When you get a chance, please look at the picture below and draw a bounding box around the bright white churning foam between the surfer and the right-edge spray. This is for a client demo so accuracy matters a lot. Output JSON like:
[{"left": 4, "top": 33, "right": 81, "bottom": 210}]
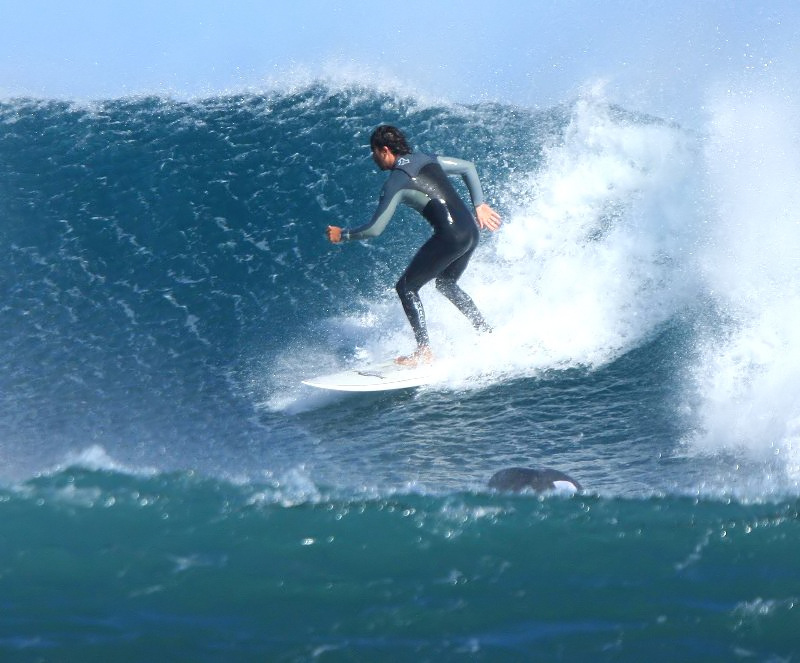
[{"left": 476, "top": 95, "right": 698, "bottom": 374}]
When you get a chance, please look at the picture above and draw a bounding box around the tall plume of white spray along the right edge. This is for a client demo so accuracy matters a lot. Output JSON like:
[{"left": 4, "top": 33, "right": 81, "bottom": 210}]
[{"left": 693, "top": 86, "right": 800, "bottom": 481}]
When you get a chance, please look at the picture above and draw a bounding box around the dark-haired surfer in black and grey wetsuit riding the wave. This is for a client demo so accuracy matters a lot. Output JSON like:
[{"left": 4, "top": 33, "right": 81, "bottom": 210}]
[{"left": 327, "top": 125, "right": 500, "bottom": 366}]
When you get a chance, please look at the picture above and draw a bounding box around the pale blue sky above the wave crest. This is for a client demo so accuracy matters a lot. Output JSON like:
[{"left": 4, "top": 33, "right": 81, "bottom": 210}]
[{"left": 0, "top": 0, "right": 800, "bottom": 123}]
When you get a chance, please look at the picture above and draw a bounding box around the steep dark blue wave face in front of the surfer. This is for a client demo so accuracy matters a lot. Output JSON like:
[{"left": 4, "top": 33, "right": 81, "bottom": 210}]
[{"left": 0, "top": 86, "right": 552, "bottom": 482}]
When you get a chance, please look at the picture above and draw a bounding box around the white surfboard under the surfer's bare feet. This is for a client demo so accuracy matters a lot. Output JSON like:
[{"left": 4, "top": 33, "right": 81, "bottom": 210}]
[{"left": 303, "top": 361, "right": 444, "bottom": 391}]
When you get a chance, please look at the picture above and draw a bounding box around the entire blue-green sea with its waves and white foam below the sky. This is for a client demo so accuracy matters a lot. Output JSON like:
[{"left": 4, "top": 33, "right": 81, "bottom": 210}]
[{"left": 0, "top": 83, "right": 800, "bottom": 662}]
